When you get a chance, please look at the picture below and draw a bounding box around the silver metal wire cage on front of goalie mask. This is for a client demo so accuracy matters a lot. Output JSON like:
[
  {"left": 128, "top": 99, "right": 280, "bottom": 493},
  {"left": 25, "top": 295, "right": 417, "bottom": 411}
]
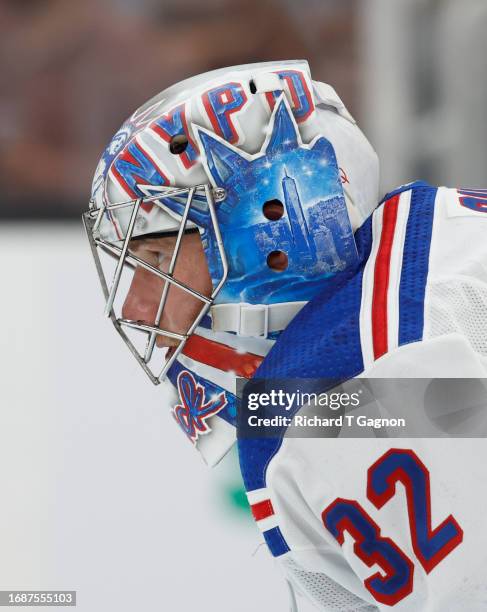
[{"left": 83, "top": 184, "right": 228, "bottom": 385}]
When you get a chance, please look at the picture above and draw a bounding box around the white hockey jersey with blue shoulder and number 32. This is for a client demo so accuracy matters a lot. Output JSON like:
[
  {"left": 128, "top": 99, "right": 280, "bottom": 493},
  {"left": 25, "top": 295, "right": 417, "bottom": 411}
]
[{"left": 239, "top": 183, "right": 487, "bottom": 612}]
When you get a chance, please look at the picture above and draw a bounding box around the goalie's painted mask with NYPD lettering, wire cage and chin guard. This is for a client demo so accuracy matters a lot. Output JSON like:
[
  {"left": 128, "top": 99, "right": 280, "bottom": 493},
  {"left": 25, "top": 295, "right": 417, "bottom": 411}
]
[{"left": 84, "top": 62, "right": 378, "bottom": 463}]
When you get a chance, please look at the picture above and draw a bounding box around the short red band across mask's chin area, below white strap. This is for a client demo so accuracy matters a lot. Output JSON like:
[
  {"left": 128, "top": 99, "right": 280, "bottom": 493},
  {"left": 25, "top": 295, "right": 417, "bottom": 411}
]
[{"left": 183, "top": 335, "right": 264, "bottom": 378}]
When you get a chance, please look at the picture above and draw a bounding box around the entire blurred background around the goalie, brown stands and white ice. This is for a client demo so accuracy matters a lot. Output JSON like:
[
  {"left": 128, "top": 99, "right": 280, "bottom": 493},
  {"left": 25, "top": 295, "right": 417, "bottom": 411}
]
[{"left": 0, "top": 0, "right": 487, "bottom": 612}]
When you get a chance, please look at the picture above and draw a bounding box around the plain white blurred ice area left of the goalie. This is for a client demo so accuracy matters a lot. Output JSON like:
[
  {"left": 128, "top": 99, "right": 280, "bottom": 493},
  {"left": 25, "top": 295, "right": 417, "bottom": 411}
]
[{"left": 0, "top": 223, "right": 316, "bottom": 612}]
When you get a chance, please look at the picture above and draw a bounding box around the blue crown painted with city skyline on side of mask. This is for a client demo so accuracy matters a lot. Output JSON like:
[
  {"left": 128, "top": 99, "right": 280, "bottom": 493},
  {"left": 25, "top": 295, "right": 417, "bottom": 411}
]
[{"left": 194, "top": 96, "right": 357, "bottom": 303}]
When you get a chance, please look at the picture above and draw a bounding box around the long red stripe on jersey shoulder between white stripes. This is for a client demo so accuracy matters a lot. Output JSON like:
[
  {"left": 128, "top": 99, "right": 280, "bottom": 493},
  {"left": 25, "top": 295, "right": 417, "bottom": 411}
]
[{"left": 372, "top": 195, "right": 399, "bottom": 359}]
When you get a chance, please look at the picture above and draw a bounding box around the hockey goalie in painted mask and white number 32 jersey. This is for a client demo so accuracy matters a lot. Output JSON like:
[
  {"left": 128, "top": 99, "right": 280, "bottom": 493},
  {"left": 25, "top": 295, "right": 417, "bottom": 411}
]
[{"left": 84, "top": 61, "right": 487, "bottom": 612}]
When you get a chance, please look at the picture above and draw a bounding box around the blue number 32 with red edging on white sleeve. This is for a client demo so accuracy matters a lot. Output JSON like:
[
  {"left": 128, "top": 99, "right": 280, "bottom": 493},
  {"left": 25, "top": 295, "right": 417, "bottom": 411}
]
[{"left": 322, "top": 449, "right": 463, "bottom": 606}]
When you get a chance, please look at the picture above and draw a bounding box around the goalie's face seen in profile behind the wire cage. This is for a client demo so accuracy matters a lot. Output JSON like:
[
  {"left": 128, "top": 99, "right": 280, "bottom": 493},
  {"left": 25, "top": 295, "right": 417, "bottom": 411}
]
[{"left": 122, "top": 232, "right": 212, "bottom": 357}]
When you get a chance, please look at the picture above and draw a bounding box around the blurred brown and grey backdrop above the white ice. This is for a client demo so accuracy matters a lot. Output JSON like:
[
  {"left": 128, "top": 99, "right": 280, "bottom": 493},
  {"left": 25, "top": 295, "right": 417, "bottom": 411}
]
[{"left": 0, "top": 0, "right": 487, "bottom": 219}]
